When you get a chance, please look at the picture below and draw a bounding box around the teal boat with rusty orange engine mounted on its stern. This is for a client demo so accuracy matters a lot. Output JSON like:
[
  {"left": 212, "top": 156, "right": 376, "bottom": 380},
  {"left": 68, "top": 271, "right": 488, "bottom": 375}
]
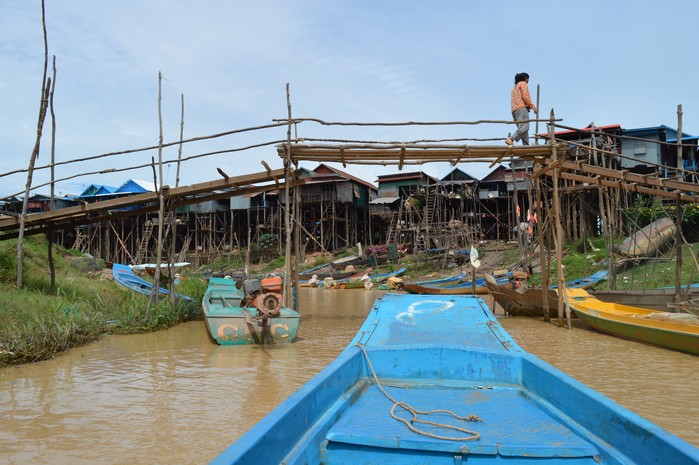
[{"left": 202, "top": 278, "right": 300, "bottom": 345}]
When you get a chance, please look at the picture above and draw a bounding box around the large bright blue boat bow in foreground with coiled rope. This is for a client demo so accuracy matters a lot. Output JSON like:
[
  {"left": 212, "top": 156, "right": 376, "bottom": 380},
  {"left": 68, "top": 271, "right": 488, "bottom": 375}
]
[{"left": 211, "top": 294, "right": 699, "bottom": 465}]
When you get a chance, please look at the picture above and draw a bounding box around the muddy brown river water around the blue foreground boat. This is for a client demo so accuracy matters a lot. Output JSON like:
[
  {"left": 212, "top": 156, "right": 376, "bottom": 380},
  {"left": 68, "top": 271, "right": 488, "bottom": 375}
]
[{"left": 0, "top": 289, "right": 699, "bottom": 464}]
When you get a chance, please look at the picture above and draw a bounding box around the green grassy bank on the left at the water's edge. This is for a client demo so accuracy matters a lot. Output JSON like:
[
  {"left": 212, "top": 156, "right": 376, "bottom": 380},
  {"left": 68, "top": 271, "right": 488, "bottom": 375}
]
[{"left": 0, "top": 236, "right": 206, "bottom": 366}]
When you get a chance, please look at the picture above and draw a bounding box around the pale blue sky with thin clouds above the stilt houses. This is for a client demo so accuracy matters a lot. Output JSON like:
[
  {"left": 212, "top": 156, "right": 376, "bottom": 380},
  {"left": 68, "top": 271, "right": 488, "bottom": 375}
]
[{"left": 0, "top": 0, "right": 699, "bottom": 197}]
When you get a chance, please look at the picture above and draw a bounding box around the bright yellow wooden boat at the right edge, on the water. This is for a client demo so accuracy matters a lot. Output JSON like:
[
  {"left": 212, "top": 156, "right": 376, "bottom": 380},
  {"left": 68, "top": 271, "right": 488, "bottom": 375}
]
[{"left": 566, "top": 289, "right": 699, "bottom": 354}]
